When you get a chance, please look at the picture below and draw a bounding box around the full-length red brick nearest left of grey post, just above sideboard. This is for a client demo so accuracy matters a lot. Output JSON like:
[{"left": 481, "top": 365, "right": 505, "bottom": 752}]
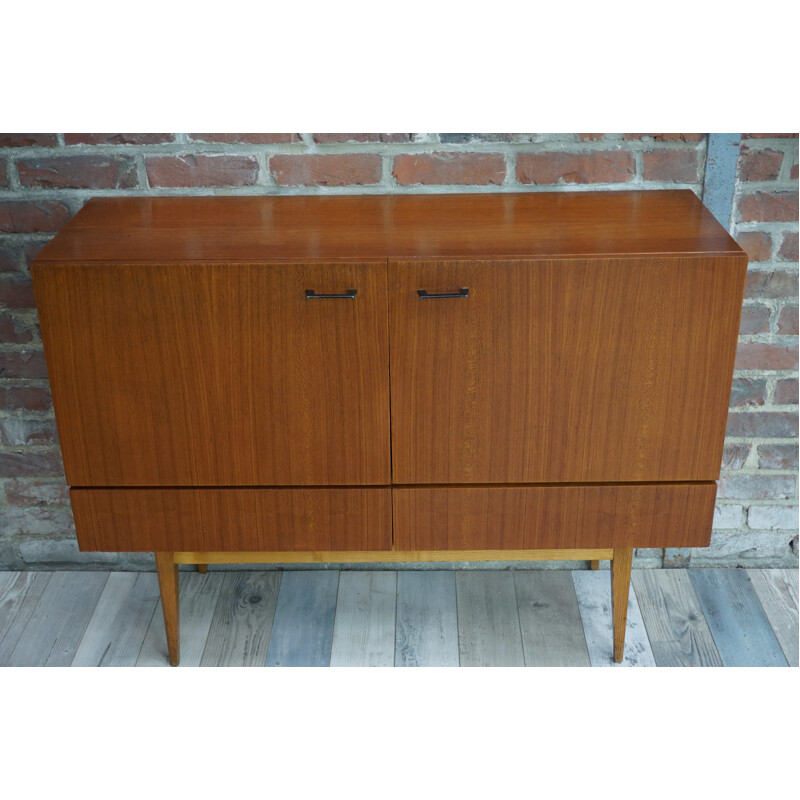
[{"left": 517, "top": 150, "right": 634, "bottom": 184}]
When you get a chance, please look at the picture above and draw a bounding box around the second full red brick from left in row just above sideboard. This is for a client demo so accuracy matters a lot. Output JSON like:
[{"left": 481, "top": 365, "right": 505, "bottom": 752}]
[{"left": 145, "top": 155, "right": 258, "bottom": 187}]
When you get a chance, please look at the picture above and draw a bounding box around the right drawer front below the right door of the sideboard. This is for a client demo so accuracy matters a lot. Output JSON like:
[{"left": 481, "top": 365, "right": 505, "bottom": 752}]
[{"left": 392, "top": 482, "right": 717, "bottom": 551}]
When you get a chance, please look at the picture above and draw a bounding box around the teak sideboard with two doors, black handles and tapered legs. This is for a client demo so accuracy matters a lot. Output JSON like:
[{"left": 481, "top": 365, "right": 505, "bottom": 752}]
[{"left": 32, "top": 191, "right": 747, "bottom": 664}]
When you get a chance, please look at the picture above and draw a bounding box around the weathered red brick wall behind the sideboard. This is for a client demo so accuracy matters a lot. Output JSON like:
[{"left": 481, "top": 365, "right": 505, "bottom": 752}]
[{"left": 0, "top": 133, "right": 798, "bottom": 568}]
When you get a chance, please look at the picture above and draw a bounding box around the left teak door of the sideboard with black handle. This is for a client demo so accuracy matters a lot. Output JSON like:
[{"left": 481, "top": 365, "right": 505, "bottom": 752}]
[{"left": 33, "top": 262, "right": 390, "bottom": 486}]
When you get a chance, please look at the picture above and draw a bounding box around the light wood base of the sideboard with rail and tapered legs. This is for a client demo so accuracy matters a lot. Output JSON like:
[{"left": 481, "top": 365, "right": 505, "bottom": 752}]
[{"left": 155, "top": 547, "right": 633, "bottom": 667}]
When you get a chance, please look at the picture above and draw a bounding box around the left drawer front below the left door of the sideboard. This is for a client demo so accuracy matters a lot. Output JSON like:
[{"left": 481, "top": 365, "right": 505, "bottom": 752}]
[{"left": 70, "top": 488, "right": 392, "bottom": 552}]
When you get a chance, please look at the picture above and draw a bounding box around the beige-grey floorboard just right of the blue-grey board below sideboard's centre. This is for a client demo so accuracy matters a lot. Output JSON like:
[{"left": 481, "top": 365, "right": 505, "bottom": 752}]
[{"left": 456, "top": 570, "right": 525, "bottom": 667}]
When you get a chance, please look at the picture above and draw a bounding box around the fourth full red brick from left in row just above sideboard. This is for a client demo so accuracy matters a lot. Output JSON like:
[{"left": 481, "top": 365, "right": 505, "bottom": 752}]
[{"left": 392, "top": 152, "right": 506, "bottom": 186}]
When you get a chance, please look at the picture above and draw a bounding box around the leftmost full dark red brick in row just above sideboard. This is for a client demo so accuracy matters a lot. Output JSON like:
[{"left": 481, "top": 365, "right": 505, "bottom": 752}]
[{"left": 17, "top": 155, "right": 139, "bottom": 189}]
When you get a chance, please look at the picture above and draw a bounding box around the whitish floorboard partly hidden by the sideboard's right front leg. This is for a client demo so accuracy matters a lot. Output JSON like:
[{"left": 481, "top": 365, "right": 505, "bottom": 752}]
[{"left": 572, "top": 570, "right": 656, "bottom": 667}]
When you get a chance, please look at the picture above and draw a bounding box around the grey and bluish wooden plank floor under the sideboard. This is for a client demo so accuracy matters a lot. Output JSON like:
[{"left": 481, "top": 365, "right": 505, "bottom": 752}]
[{"left": 0, "top": 569, "right": 798, "bottom": 667}]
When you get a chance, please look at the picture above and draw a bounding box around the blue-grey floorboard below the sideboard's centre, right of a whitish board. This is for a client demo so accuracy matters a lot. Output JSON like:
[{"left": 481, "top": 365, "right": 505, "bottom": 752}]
[{"left": 394, "top": 570, "right": 458, "bottom": 667}]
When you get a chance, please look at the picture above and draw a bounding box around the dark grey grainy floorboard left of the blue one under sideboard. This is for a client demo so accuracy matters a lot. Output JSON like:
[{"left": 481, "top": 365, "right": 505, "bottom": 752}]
[{"left": 200, "top": 571, "right": 281, "bottom": 667}]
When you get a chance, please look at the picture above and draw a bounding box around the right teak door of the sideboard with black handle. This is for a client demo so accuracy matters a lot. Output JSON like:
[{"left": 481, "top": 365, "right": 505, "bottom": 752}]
[{"left": 389, "top": 257, "right": 746, "bottom": 484}]
